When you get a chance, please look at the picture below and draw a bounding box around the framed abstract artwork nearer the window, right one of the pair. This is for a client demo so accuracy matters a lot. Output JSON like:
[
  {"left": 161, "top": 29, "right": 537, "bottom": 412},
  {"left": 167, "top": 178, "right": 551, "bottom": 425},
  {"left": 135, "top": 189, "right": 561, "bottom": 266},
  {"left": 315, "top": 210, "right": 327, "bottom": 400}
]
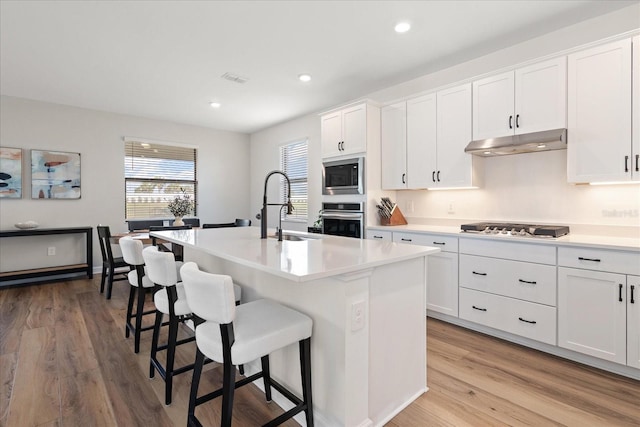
[{"left": 31, "top": 150, "right": 80, "bottom": 199}]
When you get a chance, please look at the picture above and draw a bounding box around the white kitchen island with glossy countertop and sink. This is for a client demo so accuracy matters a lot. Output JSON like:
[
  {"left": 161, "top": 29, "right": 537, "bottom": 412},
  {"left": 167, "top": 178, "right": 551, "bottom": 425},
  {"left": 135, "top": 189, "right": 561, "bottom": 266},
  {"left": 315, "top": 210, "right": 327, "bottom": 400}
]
[{"left": 151, "top": 227, "right": 439, "bottom": 427}]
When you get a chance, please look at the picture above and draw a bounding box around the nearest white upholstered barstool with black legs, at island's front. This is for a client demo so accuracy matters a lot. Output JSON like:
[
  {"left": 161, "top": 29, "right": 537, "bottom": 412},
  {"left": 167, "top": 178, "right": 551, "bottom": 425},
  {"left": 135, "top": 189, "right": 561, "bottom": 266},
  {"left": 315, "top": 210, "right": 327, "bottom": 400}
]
[{"left": 180, "top": 262, "right": 313, "bottom": 427}]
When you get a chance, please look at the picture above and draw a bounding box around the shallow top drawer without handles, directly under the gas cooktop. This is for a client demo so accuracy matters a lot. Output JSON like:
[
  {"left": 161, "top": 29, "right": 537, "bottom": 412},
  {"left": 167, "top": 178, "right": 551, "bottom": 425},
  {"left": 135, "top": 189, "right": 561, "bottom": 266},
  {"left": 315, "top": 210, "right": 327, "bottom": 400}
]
[{"left": 460, "top": 238, "right": 556, "bottom": 265}]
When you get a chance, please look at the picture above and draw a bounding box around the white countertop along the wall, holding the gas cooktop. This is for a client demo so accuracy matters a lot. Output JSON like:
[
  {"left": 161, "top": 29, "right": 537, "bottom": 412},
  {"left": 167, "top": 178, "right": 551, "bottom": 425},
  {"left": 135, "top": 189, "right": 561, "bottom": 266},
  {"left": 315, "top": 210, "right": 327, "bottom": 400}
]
[{"left": 367, "top": 224, "right": 640, "bottom": 252}]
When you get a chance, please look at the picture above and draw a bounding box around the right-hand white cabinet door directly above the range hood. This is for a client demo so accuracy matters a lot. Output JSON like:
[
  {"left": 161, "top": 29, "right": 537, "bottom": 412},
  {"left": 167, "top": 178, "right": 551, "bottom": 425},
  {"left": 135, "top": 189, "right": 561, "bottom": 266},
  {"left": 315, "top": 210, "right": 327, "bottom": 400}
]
[{"left": 514, "top": 56, "right": 567, "bottom": 134}]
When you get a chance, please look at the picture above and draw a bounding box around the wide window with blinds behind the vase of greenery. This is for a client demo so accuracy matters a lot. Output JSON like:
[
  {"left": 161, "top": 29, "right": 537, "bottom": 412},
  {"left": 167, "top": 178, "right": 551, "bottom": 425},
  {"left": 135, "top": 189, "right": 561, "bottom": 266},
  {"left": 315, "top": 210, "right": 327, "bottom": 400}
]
[{"left": 124, "top": 140, "right": 198, "bottom": 219}]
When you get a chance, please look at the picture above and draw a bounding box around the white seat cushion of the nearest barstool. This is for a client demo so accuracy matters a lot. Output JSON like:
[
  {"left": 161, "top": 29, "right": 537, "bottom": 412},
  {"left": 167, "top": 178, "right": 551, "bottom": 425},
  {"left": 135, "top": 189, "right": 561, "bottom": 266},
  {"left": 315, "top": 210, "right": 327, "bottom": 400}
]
[{"left": 196, "top": 299, "right": 313, "bottom": 365}]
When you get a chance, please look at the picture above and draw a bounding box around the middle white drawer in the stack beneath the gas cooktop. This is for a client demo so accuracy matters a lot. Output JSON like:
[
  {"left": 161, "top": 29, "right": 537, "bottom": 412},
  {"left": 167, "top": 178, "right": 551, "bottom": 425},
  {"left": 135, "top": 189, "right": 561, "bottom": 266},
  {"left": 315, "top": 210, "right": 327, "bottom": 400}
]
[{"left": 460, "top": 254, "right": 556, "bottom": 306}]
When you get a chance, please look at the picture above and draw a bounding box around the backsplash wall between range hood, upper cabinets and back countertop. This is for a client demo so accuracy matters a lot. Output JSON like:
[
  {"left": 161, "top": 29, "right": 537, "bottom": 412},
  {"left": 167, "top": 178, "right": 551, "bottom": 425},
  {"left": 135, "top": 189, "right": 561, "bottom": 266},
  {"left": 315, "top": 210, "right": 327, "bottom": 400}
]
[{"left": 396, "top": 150, "right": 640, "bottom": 231}]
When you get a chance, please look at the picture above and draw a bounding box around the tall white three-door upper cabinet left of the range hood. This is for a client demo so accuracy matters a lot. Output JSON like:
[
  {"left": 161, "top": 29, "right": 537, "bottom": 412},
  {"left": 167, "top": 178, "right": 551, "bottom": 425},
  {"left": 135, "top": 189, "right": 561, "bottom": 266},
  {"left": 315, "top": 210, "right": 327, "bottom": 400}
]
[{"left": 382, "top": 83, "right": 477, "bottom": 190}]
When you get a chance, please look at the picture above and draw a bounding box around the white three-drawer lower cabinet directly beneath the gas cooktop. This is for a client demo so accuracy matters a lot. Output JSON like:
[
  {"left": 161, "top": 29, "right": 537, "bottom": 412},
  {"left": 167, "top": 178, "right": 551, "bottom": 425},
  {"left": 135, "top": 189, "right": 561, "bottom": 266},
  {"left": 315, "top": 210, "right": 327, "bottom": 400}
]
[{"left": 459, "top": 239, "right": 557, "bottom": 345}]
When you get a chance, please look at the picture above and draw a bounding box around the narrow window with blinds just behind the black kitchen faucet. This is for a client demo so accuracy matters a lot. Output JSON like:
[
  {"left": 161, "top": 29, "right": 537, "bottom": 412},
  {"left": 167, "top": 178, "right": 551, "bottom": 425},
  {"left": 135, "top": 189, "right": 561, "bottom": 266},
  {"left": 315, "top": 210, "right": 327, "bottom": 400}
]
[{"left": 280, "top": 140, "right": 308, "bottom": 221}]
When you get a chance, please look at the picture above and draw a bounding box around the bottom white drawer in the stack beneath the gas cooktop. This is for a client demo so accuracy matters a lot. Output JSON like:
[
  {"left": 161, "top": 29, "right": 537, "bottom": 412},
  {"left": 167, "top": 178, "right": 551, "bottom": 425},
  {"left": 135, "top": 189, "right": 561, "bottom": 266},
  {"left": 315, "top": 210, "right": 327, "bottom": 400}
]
[{"left": 459, "top": 288, "right": 557, "bottom": 345}]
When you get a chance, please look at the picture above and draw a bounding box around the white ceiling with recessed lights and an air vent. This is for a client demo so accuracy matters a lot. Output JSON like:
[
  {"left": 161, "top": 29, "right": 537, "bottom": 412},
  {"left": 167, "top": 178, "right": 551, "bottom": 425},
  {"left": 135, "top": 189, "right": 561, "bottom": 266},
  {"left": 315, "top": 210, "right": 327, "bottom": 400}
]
[{"left": 0, "top": 0, "right": 638, "bottom": 133}]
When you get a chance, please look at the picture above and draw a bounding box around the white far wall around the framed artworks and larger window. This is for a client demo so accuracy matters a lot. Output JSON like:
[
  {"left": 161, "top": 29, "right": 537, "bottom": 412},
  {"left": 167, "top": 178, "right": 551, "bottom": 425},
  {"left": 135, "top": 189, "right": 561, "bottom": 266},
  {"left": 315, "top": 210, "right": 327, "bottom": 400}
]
[{"left": 0, "top": 96, "right": 250, "bottom": 269}]
